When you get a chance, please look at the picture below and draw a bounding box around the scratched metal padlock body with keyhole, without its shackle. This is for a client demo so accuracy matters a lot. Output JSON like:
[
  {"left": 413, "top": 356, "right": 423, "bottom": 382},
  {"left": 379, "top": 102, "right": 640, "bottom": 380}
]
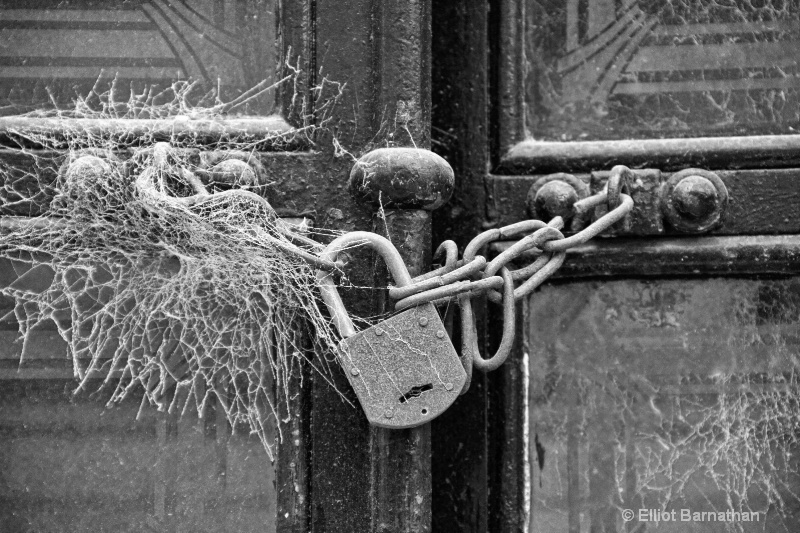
[{"left": 339, "top": 304, "right": 467, "bottom": 428}]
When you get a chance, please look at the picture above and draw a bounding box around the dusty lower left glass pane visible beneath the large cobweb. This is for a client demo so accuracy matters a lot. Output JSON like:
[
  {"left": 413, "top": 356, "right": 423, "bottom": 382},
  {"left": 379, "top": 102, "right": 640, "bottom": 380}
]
[{"left": 0, "top": 379, "right": 277, "bottom": 533}]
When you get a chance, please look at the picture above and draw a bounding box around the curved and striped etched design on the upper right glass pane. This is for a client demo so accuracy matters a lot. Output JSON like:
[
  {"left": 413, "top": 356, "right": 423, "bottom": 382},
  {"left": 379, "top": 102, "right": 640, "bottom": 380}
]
[{"left": 556, "top": 0, "right": 800, "bottom": 105}]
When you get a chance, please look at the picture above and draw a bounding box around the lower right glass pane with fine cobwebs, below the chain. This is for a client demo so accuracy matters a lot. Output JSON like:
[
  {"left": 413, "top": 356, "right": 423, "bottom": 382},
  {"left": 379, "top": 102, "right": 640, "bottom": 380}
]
[{"left": 527, "top": 279, "right": 800, "bottom": 533}]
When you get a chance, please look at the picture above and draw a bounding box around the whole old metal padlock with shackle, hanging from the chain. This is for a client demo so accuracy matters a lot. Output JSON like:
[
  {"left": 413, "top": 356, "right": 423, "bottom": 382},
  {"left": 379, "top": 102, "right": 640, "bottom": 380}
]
[{"left": 317, "top": 231, "right": 467, "bottom": 428}]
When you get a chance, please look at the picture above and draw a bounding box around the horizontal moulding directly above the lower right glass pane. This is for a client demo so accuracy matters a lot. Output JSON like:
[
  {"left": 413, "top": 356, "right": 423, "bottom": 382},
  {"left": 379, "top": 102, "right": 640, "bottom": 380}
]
[{"left": 491, "top": 235, "right": 800, "bottom": 279}]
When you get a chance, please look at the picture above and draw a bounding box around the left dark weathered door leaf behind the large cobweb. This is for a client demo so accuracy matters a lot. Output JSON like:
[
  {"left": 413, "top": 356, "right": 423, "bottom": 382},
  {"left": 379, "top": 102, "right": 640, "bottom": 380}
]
[{"left": 0, "top": 0, "right": 433, "bottom": 532}]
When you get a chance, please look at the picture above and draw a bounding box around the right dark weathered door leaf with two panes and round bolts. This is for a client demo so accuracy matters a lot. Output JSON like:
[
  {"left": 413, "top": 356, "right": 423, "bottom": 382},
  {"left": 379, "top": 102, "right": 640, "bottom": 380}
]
[{"left": 434, "top": 0, "right": 800, "bottom": 533}]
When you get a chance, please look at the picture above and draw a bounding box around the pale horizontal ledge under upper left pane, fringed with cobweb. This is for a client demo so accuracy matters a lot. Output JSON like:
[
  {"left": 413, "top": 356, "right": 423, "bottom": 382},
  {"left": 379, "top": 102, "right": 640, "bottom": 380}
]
[{"left": 0, "top": 115, "right": 307, "bottom": 150}]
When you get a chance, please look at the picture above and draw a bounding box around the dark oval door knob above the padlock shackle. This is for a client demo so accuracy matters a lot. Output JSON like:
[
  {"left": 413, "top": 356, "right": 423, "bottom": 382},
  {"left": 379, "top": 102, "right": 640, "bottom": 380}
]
[{"left": 350, "top": 148, "right": 455, "bottom": 210}]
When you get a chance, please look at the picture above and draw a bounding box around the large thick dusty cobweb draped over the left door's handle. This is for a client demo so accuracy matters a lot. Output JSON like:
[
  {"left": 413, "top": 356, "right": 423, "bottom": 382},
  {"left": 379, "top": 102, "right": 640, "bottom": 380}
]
[{"left": 0, "top": 72, "right": 354, "bottom": 458}]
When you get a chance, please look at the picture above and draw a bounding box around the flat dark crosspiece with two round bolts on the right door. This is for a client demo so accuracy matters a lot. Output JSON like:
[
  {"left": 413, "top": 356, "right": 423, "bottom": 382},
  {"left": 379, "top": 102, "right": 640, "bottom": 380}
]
[{"left": 487, "top": 164, "right": 800, "bottom": 236}]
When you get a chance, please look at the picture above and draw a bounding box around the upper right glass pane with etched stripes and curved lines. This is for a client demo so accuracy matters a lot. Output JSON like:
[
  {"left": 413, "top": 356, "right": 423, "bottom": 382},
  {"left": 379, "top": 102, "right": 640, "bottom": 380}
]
[{"left": 526, "top": 0, "right": 800, "bottom": 140}]
